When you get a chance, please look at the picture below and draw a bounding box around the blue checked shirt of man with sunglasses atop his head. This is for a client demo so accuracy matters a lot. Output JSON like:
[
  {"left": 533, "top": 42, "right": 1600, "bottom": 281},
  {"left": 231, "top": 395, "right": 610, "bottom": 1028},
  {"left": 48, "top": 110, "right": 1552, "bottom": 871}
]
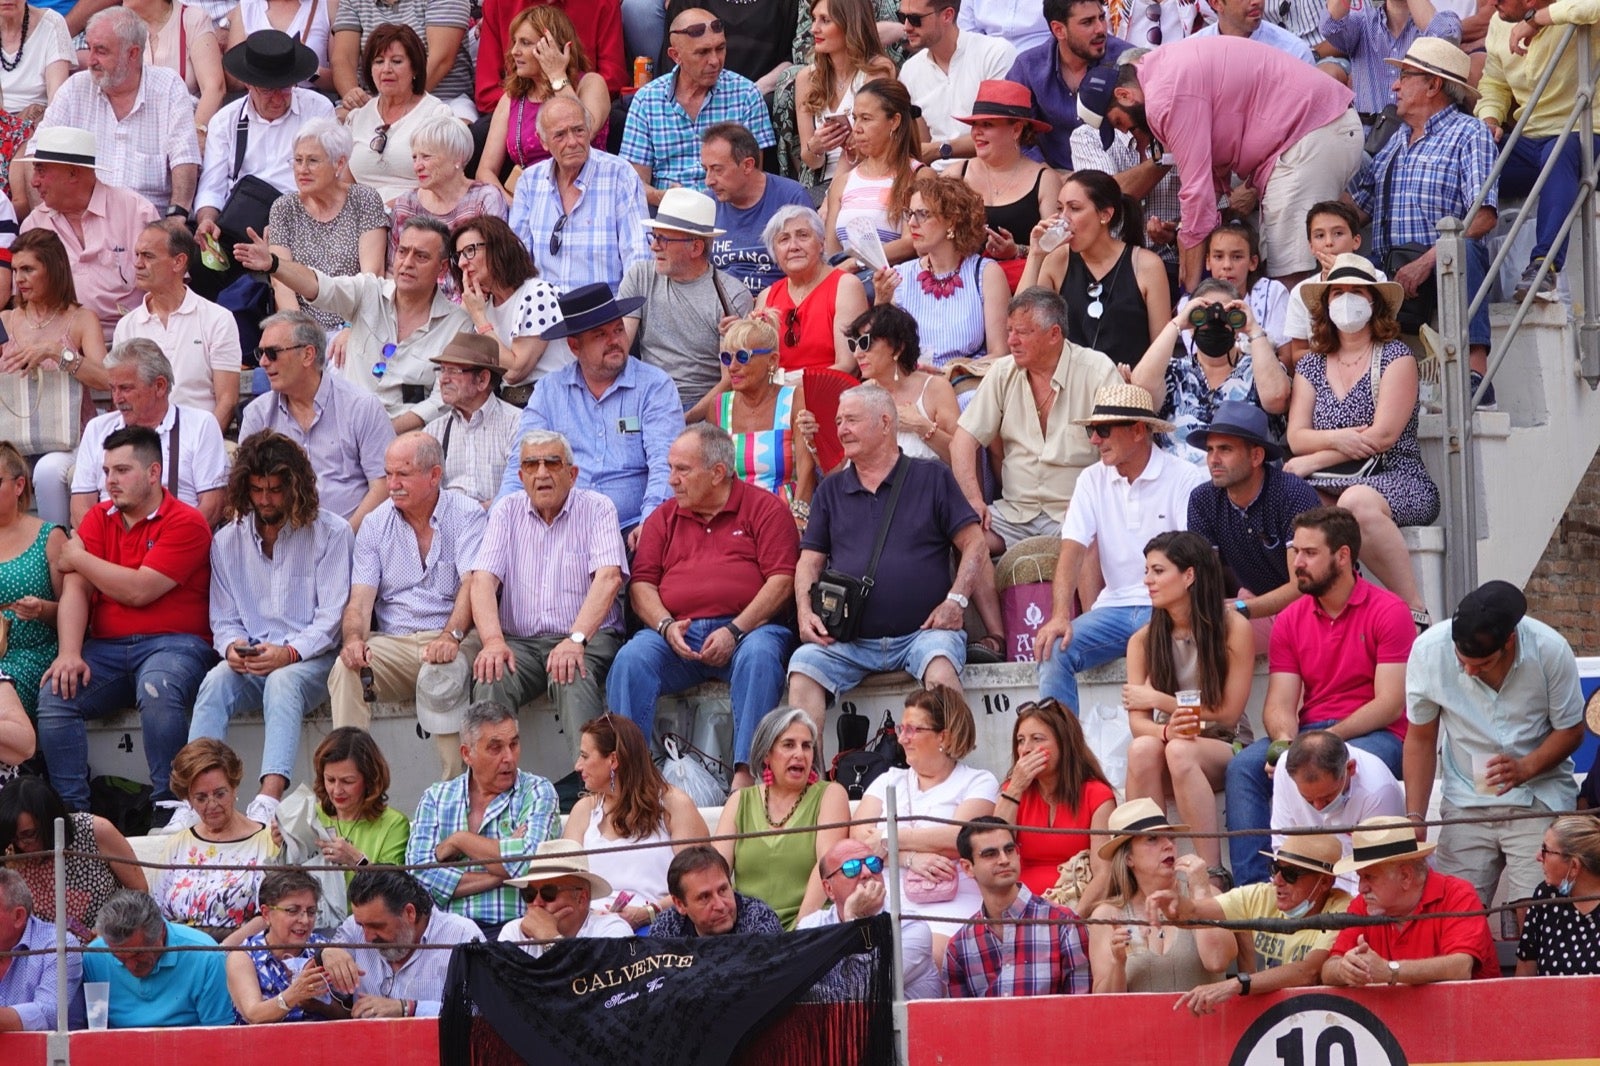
[{"left": 619, "top": 67, "right": 778, "bottom": 192}]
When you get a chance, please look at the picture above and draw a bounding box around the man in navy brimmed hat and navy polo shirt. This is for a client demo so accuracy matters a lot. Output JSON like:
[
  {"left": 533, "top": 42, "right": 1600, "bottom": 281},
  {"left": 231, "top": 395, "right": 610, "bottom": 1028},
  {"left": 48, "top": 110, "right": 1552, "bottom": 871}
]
[{"left": 1189, "top": 400, "right": 1322, "bottom": 618}]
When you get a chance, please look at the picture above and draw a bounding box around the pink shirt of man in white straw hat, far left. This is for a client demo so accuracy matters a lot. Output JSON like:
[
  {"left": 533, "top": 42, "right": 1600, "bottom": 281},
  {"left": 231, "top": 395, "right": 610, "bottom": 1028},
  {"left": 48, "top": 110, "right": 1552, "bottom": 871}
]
[{"left": 21, "top": 181, "right": 156, "bottom": 340}]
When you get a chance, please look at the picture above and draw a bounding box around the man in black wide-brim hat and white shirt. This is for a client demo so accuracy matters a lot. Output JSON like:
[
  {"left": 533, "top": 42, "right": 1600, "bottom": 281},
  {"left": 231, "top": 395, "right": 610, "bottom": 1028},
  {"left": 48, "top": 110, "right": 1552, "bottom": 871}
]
[{"left": 195, "top": 29, "right": 333, "bottom": 240}]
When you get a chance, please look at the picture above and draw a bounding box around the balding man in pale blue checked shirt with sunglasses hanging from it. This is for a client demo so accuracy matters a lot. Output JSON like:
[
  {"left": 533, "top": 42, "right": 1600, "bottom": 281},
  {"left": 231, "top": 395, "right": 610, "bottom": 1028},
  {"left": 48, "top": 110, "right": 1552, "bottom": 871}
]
[{"left": 506, "top": 96, "right": 646, "bottom": 293}]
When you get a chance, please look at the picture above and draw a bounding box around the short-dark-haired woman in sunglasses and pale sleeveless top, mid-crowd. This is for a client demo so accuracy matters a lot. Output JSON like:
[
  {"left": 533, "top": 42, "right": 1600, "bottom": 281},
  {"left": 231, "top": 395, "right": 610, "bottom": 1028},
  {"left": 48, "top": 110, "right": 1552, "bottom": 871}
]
[{"left": 845, "top": 304, "right": 962, "bottom": 463}]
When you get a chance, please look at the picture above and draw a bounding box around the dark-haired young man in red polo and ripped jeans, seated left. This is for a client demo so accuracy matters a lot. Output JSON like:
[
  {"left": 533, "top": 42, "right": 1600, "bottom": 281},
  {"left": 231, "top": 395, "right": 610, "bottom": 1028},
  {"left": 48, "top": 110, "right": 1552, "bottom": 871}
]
[{"left": 38, "top": 426, "right": 216, "bottom": 816}]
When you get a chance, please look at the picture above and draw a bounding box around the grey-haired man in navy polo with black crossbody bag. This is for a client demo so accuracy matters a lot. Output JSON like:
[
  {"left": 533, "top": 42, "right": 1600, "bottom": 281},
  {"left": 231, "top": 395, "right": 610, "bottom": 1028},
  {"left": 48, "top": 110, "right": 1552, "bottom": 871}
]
[{"left": 789, "top": 384, "right": 989, "bottom": 730}]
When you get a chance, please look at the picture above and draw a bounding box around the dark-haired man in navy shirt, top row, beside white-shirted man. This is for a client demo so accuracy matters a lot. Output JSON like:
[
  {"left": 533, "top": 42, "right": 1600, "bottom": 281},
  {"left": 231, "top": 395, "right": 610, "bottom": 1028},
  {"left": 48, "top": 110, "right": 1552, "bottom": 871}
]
[{"left": 1006, "top": 0, "right": 1133, "bottom": 170}]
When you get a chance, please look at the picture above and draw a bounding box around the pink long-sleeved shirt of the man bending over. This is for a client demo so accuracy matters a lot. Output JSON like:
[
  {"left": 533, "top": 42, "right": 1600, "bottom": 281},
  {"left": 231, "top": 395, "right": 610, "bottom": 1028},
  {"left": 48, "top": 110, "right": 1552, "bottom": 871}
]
[{"left": 1139, "top": 37, "right": 1355, "bottom": 248}]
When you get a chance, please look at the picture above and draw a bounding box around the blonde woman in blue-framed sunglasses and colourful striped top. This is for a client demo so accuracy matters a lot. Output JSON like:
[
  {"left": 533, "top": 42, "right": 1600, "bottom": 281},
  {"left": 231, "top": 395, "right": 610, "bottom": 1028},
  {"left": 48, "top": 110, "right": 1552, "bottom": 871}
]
[{"left": 712, "top": 319, "right": 816, "bottom": 527}]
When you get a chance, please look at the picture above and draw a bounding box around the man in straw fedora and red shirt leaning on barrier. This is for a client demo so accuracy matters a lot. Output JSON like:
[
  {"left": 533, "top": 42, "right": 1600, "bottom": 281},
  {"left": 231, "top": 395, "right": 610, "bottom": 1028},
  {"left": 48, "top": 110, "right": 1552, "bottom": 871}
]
[{"left": 1322, "top": 816, "right": 1499, "bottom": 988}]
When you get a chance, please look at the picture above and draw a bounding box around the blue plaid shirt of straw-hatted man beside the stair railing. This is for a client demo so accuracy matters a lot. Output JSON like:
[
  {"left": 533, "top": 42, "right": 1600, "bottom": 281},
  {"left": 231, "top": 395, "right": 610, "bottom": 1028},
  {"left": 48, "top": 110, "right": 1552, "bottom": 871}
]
[{"left": 1350, "top": 107, "right": 1499, "bottom": 262}]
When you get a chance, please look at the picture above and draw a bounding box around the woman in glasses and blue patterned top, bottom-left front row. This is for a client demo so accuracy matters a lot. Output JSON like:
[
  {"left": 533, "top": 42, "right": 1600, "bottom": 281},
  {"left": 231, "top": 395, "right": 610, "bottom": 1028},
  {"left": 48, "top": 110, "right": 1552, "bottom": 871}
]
[{"left": 227, "top": 871, "right": 350, "bottom": 1026}]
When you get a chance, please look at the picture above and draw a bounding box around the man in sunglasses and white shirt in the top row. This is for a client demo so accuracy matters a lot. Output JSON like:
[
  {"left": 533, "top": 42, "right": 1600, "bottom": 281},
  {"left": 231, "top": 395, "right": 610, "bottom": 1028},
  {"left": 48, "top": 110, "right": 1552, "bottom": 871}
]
[{"left": 899, "top": 0, "right": 1016, "bottom": 170}]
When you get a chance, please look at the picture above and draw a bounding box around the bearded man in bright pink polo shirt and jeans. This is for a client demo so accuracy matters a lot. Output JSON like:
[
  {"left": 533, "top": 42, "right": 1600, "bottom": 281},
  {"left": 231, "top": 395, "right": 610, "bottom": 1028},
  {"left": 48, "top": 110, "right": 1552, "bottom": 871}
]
[{"left": 1227, "top": 507, "right": 1416, "bottom": 885}]
